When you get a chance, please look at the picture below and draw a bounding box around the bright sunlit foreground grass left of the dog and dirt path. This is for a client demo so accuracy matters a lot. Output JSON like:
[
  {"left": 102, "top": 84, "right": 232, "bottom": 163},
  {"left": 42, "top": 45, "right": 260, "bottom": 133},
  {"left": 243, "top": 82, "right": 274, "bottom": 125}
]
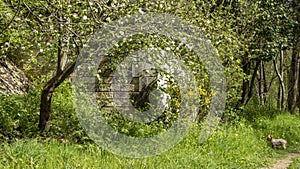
[{"left": 0, "top": 127, "right": 272, "bottom": 168}]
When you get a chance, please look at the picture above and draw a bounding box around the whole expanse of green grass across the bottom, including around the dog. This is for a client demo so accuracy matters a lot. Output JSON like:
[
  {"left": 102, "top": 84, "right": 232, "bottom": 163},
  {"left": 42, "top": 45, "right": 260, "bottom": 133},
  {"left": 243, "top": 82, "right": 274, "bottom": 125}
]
[{"left": 0, "top": 114, "right": 300, "bottom": 169}]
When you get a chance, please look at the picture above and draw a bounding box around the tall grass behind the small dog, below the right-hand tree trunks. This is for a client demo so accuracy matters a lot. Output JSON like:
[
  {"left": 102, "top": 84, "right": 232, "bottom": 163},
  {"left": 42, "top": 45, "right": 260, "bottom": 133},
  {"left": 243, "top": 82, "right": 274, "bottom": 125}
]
[{"left": 244, "top": 106, "right": 300, "bottom": 152}]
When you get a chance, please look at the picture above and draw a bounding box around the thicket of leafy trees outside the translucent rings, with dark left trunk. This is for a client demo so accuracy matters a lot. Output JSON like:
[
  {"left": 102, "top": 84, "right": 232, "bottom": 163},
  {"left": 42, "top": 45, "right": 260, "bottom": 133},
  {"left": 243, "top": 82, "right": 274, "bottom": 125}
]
[{"left": 0, "top": 0, "right": 300, "bottom": 135}]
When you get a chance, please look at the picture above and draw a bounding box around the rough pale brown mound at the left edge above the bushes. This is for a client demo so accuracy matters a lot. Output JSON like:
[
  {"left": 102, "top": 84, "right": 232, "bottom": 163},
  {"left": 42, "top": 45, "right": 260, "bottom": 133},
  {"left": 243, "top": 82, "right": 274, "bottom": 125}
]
[{"left": 0, "top": 58, "right": 29, "bottom": 95}]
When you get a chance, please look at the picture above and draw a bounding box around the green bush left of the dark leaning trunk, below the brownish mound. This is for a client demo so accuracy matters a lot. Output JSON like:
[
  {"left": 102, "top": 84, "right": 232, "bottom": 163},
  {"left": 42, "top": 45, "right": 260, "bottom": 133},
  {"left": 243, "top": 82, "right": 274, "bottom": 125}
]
[{"left": 0, "top": 90, "right": 40, "bottom": 137}]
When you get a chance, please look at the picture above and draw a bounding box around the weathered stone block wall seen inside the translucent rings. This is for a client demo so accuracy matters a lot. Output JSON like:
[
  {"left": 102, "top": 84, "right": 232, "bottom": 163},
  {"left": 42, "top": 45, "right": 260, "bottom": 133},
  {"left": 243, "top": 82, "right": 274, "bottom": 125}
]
[{"left": 96, "top": 62, "right": 157, "bottom": 109}]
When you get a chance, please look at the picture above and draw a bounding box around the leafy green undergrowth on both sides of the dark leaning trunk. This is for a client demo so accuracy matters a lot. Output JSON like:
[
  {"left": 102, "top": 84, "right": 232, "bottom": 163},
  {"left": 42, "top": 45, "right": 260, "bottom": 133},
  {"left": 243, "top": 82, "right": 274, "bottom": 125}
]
[{"left": 0, "top": 82, "right": 87, "bottom": 142}]
